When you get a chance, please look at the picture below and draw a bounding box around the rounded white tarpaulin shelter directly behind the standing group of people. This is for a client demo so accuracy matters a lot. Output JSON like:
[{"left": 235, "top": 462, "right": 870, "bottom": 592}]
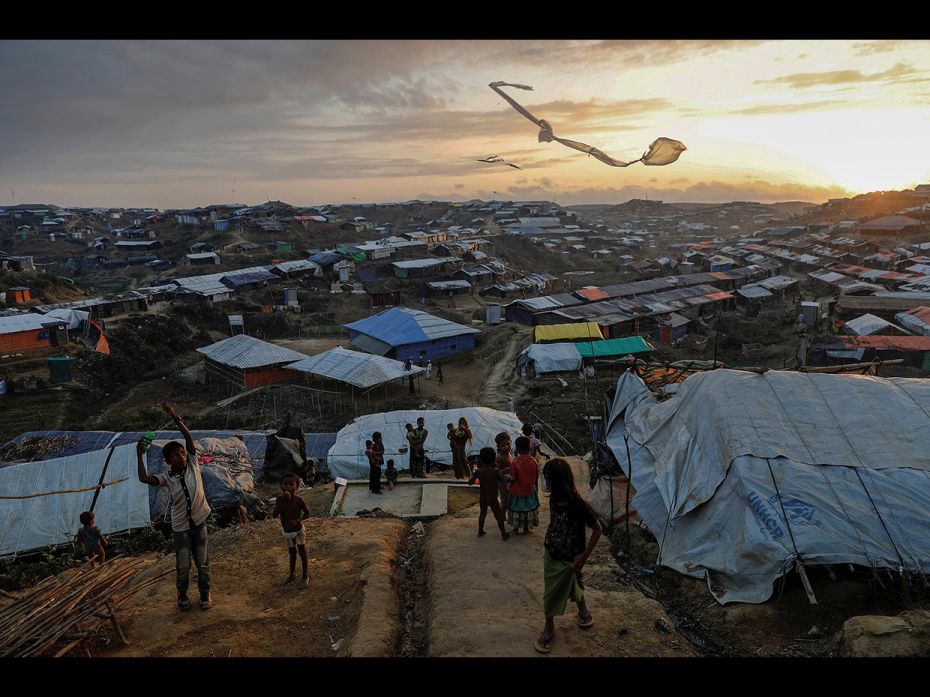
[{"left": 327, "top": 407, "right": 523, "bottom": 479}]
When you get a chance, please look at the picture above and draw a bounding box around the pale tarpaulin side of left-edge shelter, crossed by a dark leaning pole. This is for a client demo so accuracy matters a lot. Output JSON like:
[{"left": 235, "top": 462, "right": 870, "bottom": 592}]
[{"left": 0, "top": 444, "right": 151, "bottom": 554}]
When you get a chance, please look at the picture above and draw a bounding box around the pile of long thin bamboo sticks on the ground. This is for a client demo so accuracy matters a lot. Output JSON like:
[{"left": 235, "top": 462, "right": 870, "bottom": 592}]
[{"left": 0, "top": 557, "right": 172, "bottom": 657}]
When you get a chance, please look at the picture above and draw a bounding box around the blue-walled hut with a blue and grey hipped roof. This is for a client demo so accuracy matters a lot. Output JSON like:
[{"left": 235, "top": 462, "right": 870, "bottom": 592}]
[{"left": 344, "top": 307, "right": 481, "bottom": 361}]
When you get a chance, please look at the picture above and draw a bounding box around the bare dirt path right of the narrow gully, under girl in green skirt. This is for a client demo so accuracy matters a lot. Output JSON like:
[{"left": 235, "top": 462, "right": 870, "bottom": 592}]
[{"left": 425, "top": 458, "right": 694, "bottom": 656}]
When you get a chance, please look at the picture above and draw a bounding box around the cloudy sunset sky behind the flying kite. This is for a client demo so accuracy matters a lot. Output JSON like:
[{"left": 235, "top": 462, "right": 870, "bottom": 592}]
[{"left": 0, "top": 40, "right": 930, "bottom": 208}]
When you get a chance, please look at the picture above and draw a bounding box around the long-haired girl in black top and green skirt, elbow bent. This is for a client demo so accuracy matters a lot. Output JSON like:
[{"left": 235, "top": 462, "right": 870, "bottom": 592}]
[{"left": 536, "top": 456, "right": 602, "bottom": 653}]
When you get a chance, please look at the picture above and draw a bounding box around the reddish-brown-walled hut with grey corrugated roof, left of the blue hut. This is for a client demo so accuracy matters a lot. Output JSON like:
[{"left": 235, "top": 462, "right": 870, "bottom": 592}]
[{"left": 197, "top": 334, "right": 306, "bottom": 391}]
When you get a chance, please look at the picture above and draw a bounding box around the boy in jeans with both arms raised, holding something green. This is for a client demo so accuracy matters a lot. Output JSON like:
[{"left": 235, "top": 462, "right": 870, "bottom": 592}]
[{"left": 136, "top": 402, "right": 213, "bottom": 610}]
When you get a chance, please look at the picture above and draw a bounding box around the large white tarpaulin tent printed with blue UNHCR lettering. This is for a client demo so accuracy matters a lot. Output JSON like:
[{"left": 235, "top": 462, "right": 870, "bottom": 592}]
[{"left": 607, "top": 370, "right": 930, "bottom": 603}]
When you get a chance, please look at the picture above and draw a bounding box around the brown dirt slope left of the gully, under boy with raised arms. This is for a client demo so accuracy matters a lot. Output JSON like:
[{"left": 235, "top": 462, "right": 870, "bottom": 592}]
[{"left": 103, "top": 508, "right": 406, "bottom": 657}]
